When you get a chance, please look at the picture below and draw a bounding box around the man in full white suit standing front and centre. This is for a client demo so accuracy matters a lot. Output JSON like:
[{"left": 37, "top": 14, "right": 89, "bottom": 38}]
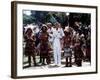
[{"left": 52, "top": 23, "right": 64, "bottom": 66}]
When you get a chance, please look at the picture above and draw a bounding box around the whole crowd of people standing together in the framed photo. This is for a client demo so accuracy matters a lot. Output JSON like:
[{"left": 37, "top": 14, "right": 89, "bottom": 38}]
[{"left": 24, "top": 22, "right": 91, "bottom": 67}]
